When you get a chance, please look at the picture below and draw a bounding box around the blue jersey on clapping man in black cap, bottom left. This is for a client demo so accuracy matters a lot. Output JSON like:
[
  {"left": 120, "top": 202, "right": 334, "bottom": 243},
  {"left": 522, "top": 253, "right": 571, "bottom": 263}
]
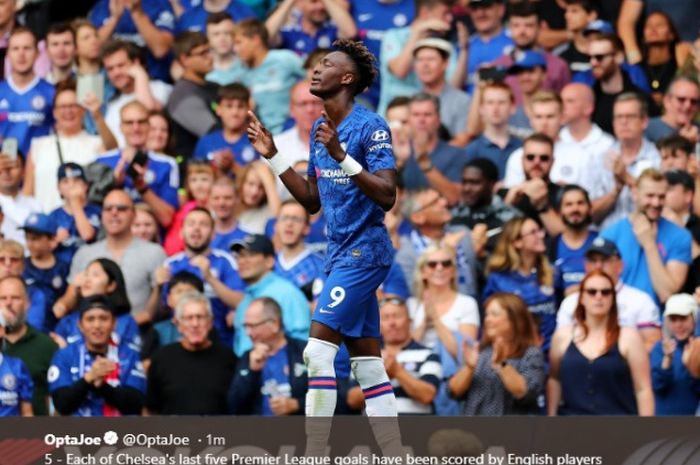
[{"left": 46, "top": 342, "right": 146, "bottom": 417}]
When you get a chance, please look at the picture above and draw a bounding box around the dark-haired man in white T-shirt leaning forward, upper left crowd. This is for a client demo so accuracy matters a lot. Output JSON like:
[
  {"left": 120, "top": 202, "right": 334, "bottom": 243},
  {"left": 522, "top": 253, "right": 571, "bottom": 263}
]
[{"left": 102, "top": 41, "right": 172, "bottom": 147}]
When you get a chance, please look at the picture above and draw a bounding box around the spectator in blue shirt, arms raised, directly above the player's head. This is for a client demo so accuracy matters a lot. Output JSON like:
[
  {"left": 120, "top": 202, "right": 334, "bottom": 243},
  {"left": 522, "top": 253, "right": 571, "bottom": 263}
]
[{"left": 265, "top": 0, "right": 357, "bottom": 57}]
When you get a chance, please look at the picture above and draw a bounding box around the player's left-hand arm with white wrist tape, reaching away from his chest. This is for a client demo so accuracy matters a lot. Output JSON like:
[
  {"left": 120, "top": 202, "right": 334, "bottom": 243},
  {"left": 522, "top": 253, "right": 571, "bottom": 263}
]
[{"left": 247, "top": 111, "right": 321, "bottom": 214}]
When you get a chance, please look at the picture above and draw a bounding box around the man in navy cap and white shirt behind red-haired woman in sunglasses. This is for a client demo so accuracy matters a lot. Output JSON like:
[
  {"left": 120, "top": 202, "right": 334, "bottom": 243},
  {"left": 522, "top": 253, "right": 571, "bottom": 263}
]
[{"left": 557, "top": 237, "right": 661, "bottom": 351}]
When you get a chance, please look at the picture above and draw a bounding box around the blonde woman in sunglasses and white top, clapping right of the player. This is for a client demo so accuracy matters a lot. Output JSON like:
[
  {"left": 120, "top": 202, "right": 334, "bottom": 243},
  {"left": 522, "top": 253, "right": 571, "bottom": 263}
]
[{"left": 407, "top": 245, "right": 479, "bottom": 357}]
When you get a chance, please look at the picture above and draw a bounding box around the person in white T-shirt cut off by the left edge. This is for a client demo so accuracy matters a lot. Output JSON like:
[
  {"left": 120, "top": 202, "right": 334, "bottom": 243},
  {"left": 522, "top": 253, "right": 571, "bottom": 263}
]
[{"left": 0, "top": 154, "right": 41, "bottom": 245}]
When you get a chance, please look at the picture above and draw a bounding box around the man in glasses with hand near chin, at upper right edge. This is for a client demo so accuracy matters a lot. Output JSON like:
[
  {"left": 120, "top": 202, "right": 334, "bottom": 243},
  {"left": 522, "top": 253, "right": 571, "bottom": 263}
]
[{"left": 645, "top": 75, "right": 700, "bottom": 143}]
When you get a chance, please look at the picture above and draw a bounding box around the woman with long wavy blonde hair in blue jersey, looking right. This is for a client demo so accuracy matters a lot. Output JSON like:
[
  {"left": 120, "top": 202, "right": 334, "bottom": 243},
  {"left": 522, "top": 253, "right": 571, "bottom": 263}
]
[{"left": 483, "top": 217, "right": 557, "bottom": 353}]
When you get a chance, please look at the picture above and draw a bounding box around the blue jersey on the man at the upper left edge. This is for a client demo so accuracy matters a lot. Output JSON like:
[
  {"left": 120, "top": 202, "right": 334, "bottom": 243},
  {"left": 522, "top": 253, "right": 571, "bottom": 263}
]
[{"left": 0, "top": 77, "right": 55, "bottom": 157}]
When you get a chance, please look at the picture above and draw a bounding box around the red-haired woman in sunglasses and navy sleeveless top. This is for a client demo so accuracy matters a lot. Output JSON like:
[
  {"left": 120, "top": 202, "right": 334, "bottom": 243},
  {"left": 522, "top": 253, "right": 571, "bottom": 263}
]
[{"left": 547, "top": 271, "right": 654, "bottom": 416}]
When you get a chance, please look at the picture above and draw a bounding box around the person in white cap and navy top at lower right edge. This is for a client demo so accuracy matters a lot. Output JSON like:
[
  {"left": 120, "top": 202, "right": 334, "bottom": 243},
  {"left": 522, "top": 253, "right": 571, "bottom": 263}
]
[{"left": 651, "top": 294, "right": 700, "bottom": 415}]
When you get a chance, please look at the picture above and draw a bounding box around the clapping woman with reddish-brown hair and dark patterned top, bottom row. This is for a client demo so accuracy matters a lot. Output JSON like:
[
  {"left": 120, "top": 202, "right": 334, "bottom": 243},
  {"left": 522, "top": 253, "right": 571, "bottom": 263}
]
[{"left": 448, "top": 292, "right": 545, "bottom": 415}]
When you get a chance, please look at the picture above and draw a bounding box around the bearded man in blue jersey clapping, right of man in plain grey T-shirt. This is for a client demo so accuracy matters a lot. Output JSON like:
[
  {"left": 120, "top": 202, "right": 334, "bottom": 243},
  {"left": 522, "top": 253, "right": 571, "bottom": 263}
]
[{"left": 163, "top": 207, "right": 244, "bottom": 347}]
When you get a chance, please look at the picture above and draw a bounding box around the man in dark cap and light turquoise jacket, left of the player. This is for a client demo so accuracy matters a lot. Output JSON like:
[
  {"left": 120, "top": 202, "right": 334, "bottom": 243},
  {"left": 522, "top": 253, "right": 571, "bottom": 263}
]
[{"left": 231, "top": 234, "right": 311, "bottom": 357}]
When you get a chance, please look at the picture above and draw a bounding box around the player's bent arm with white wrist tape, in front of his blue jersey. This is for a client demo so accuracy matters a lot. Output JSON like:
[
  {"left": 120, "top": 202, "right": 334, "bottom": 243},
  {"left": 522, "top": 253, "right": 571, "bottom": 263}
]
[{"left": 314, "top": 111, "right": 397, "bottom": 211}]
